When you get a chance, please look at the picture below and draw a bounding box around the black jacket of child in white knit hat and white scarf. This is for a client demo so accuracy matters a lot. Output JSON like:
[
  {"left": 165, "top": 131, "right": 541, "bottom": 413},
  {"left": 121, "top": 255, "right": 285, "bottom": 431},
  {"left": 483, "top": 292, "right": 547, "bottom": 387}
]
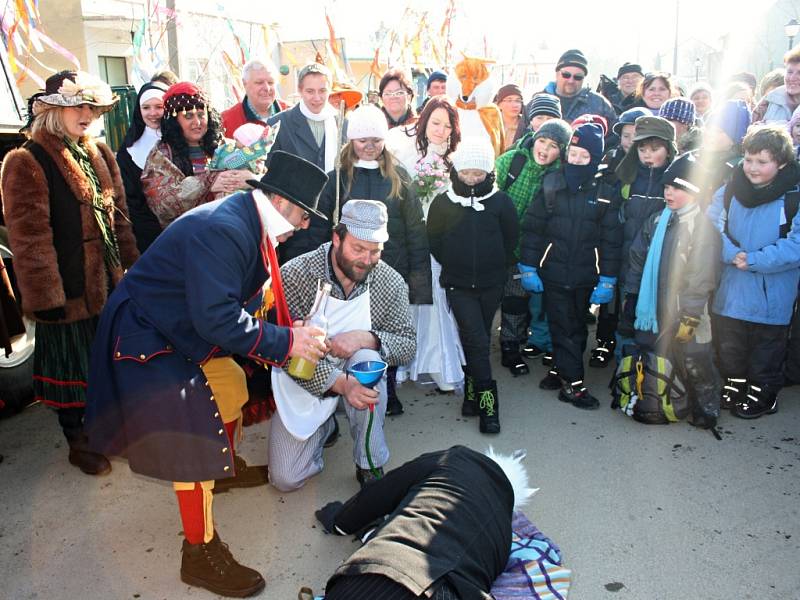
[{"left": 428, "top": 190, "right": 519, "bottom": 289}]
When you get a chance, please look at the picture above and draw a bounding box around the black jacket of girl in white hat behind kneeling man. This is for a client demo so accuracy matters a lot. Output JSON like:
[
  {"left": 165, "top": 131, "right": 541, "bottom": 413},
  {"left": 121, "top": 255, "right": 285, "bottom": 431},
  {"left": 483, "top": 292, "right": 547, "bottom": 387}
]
[{"left": 309, "top": 167, "right": 433, "bottom": 304}]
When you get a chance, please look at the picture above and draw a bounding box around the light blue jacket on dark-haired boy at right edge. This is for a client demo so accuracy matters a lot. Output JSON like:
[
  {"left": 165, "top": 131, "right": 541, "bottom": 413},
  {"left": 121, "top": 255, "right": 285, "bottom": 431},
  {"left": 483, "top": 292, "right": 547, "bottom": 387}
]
[{"left": 708, "top": 162, "right": 800, "bottom": 325}]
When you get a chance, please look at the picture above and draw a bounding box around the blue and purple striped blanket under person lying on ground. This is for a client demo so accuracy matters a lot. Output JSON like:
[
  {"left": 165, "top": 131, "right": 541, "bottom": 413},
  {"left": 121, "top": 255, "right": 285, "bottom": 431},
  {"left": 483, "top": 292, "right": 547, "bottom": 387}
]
[{"left": 491, "top": 512, "right": 572, "bottom": 600}]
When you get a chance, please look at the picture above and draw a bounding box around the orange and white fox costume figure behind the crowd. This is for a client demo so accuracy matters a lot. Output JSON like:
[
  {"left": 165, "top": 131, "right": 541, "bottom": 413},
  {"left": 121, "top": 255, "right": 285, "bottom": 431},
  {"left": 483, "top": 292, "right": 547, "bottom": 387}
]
[{"left": 447, "top": 56, "right": 505, "bottom": 157}]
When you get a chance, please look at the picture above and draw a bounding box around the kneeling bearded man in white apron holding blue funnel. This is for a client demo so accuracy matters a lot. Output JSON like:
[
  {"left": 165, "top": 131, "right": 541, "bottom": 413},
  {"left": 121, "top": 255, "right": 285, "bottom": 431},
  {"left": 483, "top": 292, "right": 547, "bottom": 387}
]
[{"left": 269, "top": 200, "right": 416, "bottom": 492}]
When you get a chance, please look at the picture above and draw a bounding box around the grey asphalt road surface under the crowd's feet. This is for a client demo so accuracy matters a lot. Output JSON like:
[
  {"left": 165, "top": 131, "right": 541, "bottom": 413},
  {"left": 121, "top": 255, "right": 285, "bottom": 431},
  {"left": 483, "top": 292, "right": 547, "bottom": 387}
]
[{"left": 0, "top": 342, "right": 800, "bottom": 600}]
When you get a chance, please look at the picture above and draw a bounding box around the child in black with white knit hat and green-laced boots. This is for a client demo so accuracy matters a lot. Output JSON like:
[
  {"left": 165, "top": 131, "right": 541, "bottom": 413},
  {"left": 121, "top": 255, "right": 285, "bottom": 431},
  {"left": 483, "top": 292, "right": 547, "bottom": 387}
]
[{"left": 428, "top": 139, "right": 519, "bottom": 433}]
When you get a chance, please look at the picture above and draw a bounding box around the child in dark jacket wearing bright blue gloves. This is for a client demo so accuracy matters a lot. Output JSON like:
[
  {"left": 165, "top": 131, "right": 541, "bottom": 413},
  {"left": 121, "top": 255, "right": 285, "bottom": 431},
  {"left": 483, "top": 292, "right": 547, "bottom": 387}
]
[{"left": 519, "top": 123, "right": 622, "bottom": 409}]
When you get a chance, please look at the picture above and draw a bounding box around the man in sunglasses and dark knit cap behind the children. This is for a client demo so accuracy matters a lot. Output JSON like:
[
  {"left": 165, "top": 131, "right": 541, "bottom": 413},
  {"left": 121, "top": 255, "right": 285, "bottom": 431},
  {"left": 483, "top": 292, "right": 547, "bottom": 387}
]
[{"left": 544, "top": 49, "right": 617, "bottom": 129}]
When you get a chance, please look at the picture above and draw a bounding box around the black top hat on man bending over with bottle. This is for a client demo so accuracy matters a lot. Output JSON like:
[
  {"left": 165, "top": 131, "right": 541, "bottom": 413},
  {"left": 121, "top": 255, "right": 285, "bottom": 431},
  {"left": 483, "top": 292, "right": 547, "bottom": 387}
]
[{"left": 247, "top": 150, "right": 328, "bottom": 221}]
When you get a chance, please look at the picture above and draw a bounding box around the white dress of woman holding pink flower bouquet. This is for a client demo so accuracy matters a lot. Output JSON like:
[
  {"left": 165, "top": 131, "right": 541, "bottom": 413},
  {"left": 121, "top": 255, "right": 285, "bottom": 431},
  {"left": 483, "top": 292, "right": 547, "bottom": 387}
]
[{"left": 386, "top": 125, "right": 464, "bottom": 390}]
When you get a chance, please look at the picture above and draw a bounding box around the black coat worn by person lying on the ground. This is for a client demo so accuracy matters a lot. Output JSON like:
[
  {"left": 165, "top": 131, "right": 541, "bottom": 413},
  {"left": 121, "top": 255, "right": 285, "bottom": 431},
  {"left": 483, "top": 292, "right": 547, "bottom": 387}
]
[{"left": 327, "top": 446, "right": 514, "bottom": 600}]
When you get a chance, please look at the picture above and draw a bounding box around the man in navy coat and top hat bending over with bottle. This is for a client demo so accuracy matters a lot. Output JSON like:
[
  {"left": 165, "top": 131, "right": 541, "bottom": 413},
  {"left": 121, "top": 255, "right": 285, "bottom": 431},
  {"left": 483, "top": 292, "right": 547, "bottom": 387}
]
[{"left": 86, "top": 152, "right": 327, "bottom": 597}]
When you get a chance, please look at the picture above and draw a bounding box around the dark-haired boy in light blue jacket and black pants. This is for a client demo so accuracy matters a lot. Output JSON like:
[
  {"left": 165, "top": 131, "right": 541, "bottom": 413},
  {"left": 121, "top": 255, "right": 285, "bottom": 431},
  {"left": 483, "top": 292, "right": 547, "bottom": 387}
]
[{"left": 708, "top": 125, "right": 800, "bottom": 419}]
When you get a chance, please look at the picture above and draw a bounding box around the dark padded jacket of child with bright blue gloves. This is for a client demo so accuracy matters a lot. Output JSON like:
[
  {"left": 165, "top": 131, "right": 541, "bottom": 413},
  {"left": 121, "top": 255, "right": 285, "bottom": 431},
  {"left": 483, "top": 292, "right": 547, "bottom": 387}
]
[{"left": 520, "top": 168, "right": 622, "bottom": 288}]
